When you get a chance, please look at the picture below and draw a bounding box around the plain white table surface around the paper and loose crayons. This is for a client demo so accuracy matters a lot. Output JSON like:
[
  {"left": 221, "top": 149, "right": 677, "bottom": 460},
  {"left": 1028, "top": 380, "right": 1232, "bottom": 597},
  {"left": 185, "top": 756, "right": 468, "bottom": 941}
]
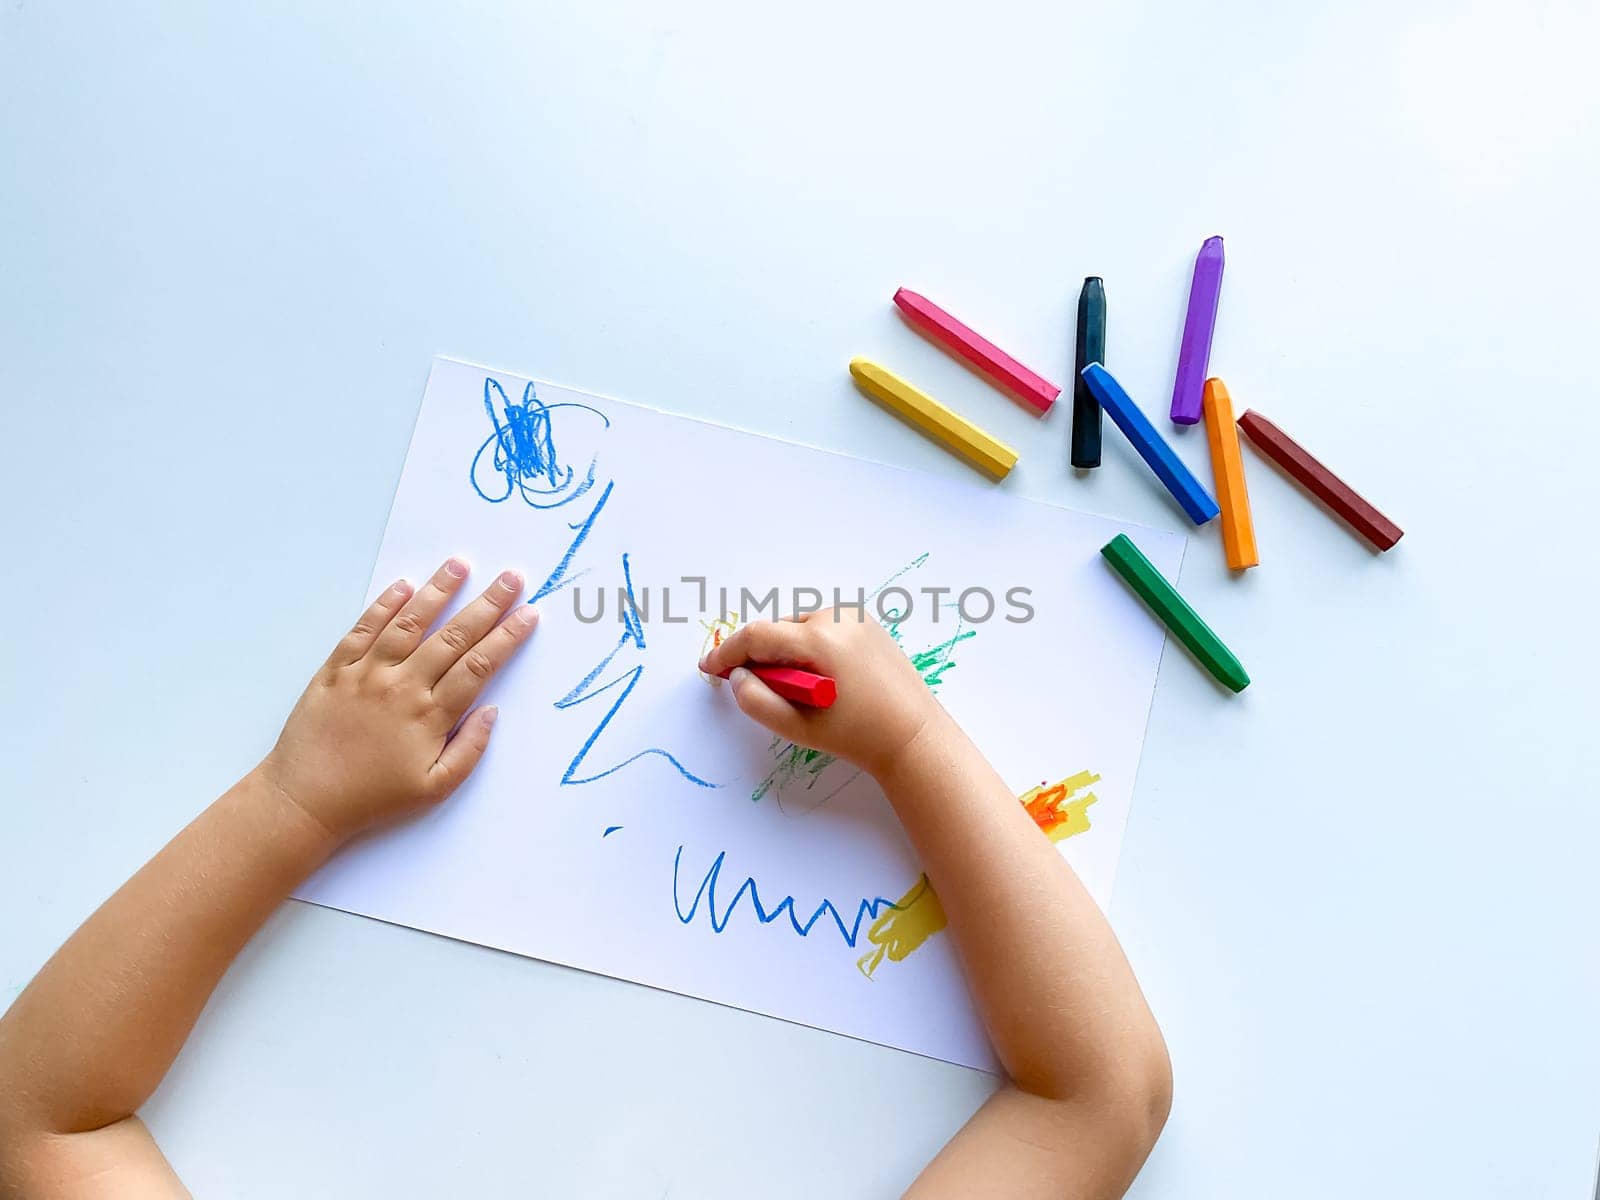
[{"left": 0, "top": 0, "right": 1600, "bottom": 1200}]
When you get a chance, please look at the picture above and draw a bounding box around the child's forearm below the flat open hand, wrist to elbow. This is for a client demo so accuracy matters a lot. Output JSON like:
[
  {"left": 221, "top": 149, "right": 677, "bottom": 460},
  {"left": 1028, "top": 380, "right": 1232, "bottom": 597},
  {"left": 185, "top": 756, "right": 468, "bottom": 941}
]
[{"left": 0, "top": 771, "right": 334, "bottom": 1133}]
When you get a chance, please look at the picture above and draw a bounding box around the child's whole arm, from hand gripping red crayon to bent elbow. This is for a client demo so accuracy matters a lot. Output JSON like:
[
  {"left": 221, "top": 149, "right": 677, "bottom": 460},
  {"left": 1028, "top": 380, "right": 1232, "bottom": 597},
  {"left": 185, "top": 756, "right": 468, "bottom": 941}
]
[{"left": 701, "top": 608, "right": 1171, "bottom": 1200}]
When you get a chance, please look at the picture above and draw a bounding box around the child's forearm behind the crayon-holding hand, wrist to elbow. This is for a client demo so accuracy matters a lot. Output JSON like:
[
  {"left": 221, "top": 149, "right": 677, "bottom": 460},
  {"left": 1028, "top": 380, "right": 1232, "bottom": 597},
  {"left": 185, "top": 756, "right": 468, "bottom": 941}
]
[{"left": 878, "top": 710, "right": 1170, "bottom": 1138}]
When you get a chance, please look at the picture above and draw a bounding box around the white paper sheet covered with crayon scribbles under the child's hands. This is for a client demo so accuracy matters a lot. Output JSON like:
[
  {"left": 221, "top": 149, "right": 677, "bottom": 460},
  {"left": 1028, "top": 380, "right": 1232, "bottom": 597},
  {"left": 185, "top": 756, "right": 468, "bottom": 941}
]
[{"left": 299, "top": 358, "right": 1182, "bottom": 1069}]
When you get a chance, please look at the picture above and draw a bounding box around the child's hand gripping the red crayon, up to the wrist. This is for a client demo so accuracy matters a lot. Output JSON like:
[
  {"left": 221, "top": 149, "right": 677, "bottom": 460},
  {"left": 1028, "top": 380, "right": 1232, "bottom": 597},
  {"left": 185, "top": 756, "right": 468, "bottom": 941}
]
[{"left": 701, "top": 608, "right": 944, "bottom": 774}]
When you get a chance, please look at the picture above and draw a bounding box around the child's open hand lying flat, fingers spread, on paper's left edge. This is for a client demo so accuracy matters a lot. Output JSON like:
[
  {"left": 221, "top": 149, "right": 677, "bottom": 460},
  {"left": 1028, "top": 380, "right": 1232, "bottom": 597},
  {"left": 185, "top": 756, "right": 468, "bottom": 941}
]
[{"left": 259, "top": 558, "right": 538, "bottom": 840}]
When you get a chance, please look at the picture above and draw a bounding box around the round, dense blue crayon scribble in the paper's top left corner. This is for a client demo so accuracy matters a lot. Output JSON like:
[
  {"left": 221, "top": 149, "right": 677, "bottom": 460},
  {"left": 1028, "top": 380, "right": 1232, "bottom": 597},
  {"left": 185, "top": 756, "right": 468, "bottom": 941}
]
[{"left": 469, "top": 379, "right": 611, "bottom": 509}]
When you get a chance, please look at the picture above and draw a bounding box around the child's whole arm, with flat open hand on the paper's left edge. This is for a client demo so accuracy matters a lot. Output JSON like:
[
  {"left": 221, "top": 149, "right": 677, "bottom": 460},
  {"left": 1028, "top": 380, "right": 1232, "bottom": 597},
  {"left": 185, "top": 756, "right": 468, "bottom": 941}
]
[{"left": 0, "top": 560, "right": 534, "bottom": 1200}]
